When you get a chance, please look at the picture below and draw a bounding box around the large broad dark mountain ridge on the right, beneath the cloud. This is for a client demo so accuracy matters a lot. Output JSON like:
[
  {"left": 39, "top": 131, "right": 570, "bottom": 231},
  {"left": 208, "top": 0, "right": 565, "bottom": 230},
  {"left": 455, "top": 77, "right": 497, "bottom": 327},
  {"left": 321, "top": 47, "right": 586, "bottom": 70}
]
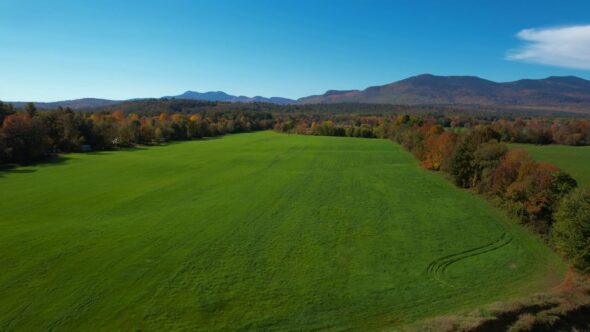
[{"left": 297, "top": 74, "right": 590, "bottom": 106}]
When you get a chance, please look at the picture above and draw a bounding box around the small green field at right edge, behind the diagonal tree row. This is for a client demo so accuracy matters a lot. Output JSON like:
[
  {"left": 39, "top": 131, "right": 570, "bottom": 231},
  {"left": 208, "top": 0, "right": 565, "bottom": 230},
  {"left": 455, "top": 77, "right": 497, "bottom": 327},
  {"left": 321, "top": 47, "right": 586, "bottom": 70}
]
[{"left": 511, "top": 144, "right": 590, "bottom": 187}]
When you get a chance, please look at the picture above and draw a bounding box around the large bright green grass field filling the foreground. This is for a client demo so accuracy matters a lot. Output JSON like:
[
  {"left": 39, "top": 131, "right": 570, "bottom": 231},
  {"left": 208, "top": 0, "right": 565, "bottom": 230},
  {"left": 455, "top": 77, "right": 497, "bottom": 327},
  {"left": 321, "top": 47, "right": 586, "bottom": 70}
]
[{"left": 0, "top": 132, "right": 565, "bottom": 331}]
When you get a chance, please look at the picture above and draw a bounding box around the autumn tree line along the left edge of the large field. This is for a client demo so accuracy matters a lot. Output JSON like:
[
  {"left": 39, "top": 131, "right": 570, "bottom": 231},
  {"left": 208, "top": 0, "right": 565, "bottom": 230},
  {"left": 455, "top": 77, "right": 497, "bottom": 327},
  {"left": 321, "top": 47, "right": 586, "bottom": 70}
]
[{"left": 0, "top": 103, "right": 274, "bottom": 165}]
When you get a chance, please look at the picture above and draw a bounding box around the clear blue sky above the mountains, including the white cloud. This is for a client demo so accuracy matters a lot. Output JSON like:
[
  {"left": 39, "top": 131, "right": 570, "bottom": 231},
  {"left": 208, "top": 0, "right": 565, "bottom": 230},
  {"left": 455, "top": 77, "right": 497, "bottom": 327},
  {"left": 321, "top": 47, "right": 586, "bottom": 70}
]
[{"left": 0, "top": 0, "right": 590, "bottom": 101}]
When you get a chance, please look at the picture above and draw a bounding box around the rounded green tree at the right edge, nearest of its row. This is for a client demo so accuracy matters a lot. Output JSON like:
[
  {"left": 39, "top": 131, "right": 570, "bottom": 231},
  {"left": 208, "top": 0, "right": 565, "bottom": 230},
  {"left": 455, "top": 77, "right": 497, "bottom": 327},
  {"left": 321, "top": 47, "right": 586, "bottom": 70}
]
[{"left": 552, "top": 188, "right": 590, "bottom": 273}]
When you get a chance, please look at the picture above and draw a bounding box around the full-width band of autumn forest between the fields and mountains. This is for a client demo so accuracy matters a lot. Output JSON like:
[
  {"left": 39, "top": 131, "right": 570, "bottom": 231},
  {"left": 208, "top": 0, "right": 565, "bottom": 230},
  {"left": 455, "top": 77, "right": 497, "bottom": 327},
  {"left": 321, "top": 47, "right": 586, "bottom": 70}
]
[{"left": 0, "top": 100, "right": 590, "bottom": 164}]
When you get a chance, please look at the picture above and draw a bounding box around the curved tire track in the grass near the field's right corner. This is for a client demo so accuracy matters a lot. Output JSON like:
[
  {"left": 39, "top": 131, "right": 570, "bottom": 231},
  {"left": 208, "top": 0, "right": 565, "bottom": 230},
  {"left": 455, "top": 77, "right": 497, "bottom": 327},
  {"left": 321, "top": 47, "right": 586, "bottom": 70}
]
[{"left": 426, "top": 232, "right": 512, "bottom": 285}]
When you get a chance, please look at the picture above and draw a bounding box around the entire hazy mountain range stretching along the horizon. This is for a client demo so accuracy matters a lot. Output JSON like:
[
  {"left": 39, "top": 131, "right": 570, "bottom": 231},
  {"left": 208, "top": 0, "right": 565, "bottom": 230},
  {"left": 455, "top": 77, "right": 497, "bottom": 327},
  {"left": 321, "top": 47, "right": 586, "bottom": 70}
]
[{"left": 8, "top": 74, "right": 590, "bottom": 109}]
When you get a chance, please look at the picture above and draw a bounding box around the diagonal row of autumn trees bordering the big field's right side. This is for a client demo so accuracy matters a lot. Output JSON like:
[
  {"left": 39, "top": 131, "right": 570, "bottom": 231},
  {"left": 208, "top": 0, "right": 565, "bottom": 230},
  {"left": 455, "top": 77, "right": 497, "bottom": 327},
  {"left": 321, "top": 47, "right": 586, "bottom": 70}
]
[{"left": 392, "top": 116, "right": 590, "bottom": 273}]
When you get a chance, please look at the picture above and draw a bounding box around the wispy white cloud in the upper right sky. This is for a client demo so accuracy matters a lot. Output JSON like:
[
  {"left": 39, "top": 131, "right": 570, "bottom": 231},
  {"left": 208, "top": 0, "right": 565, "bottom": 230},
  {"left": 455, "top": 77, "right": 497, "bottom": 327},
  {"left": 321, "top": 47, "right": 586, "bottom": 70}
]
[{"left": 506, "top": 25, "right": 590, "bottom": 70}]
